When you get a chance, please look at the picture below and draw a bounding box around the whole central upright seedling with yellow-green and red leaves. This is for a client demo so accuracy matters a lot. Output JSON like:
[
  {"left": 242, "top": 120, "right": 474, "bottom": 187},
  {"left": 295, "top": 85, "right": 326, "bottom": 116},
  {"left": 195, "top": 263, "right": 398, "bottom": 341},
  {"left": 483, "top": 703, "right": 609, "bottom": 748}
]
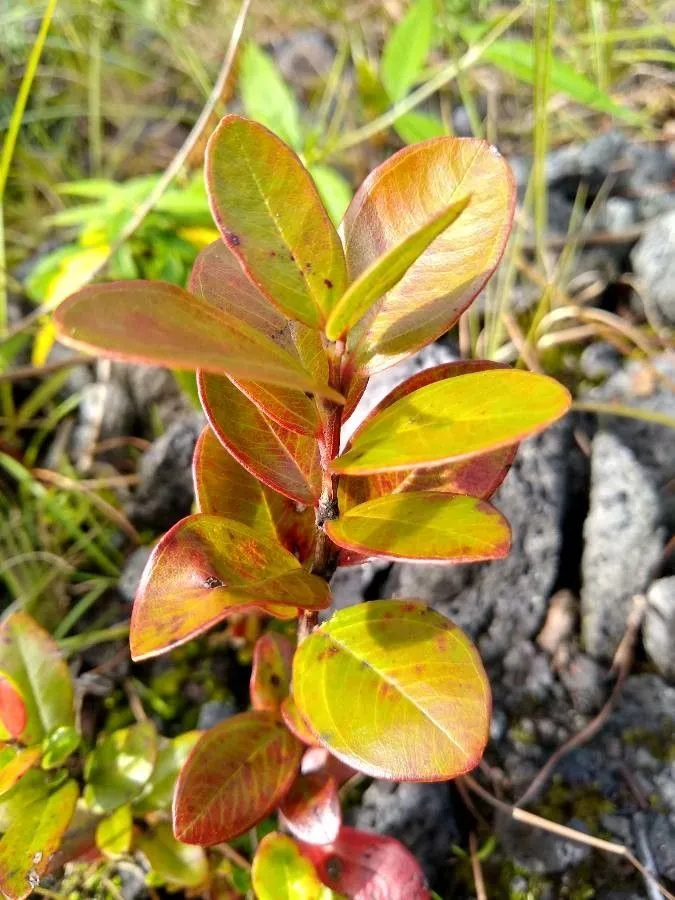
[{"left": 50, "top": 115, "right": 569, "bottom": 900}]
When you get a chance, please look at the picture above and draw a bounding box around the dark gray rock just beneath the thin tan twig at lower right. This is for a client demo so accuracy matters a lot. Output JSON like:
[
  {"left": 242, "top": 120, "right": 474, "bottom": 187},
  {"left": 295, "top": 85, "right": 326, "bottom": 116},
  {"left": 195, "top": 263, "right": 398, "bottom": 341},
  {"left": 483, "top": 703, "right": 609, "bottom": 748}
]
[{"left": 495, "top": 815, "right": 591, "bottom": 875}]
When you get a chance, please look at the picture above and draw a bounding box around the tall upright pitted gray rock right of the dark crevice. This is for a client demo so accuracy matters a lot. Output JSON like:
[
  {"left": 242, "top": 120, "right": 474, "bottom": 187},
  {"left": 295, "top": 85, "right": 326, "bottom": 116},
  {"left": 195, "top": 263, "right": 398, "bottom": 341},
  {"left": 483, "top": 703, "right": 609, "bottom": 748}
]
[{"left": 581, "top": 432, "right": 664, "bottom": 660}]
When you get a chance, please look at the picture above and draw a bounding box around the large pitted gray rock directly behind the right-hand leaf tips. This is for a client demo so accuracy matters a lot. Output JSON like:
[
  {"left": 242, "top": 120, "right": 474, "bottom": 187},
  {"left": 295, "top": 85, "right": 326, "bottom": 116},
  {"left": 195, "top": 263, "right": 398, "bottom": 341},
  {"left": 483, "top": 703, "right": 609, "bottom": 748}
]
[{"left": 387, "top": 421, "right": 570, "bottom": 661}]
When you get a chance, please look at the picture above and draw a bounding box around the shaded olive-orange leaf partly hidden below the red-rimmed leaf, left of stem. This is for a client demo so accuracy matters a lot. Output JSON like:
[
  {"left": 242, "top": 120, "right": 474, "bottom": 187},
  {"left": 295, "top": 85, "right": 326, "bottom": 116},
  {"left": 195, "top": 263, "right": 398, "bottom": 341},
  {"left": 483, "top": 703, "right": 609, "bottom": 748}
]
[{"left": 192, "top": 426, "right": 314, "bottom": 562}]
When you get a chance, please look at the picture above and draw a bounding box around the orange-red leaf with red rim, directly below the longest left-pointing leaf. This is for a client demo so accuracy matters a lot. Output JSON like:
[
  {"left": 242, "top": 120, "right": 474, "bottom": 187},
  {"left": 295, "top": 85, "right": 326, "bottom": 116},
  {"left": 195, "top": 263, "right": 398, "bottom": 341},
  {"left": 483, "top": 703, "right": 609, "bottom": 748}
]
[{"left": 198, "top": 372, "right": 321, "bottom": 506}]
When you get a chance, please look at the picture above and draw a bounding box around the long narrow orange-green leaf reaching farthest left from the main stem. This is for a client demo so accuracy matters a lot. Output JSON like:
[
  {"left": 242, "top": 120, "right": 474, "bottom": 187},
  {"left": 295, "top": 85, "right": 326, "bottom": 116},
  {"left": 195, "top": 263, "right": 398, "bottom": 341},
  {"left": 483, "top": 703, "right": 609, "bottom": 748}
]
[{"left": 54, "top": 281, "right": 341, "bottom": 402}]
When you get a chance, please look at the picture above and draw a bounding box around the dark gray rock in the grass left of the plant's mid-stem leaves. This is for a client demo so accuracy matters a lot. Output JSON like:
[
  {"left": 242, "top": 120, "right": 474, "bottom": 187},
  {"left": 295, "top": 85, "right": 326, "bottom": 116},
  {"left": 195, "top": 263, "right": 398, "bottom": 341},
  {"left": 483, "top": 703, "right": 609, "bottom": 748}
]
[{"left": 128, "top": 414, "right": 204, "bottom": 531}]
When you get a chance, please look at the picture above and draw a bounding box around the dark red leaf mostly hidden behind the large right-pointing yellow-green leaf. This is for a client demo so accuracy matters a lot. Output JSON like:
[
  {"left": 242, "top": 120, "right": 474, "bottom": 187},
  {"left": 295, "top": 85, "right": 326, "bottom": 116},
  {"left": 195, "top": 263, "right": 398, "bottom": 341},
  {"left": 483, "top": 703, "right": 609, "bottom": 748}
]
[{"left": 338, "top": 359, "right": 518, "bottom": 512}]
